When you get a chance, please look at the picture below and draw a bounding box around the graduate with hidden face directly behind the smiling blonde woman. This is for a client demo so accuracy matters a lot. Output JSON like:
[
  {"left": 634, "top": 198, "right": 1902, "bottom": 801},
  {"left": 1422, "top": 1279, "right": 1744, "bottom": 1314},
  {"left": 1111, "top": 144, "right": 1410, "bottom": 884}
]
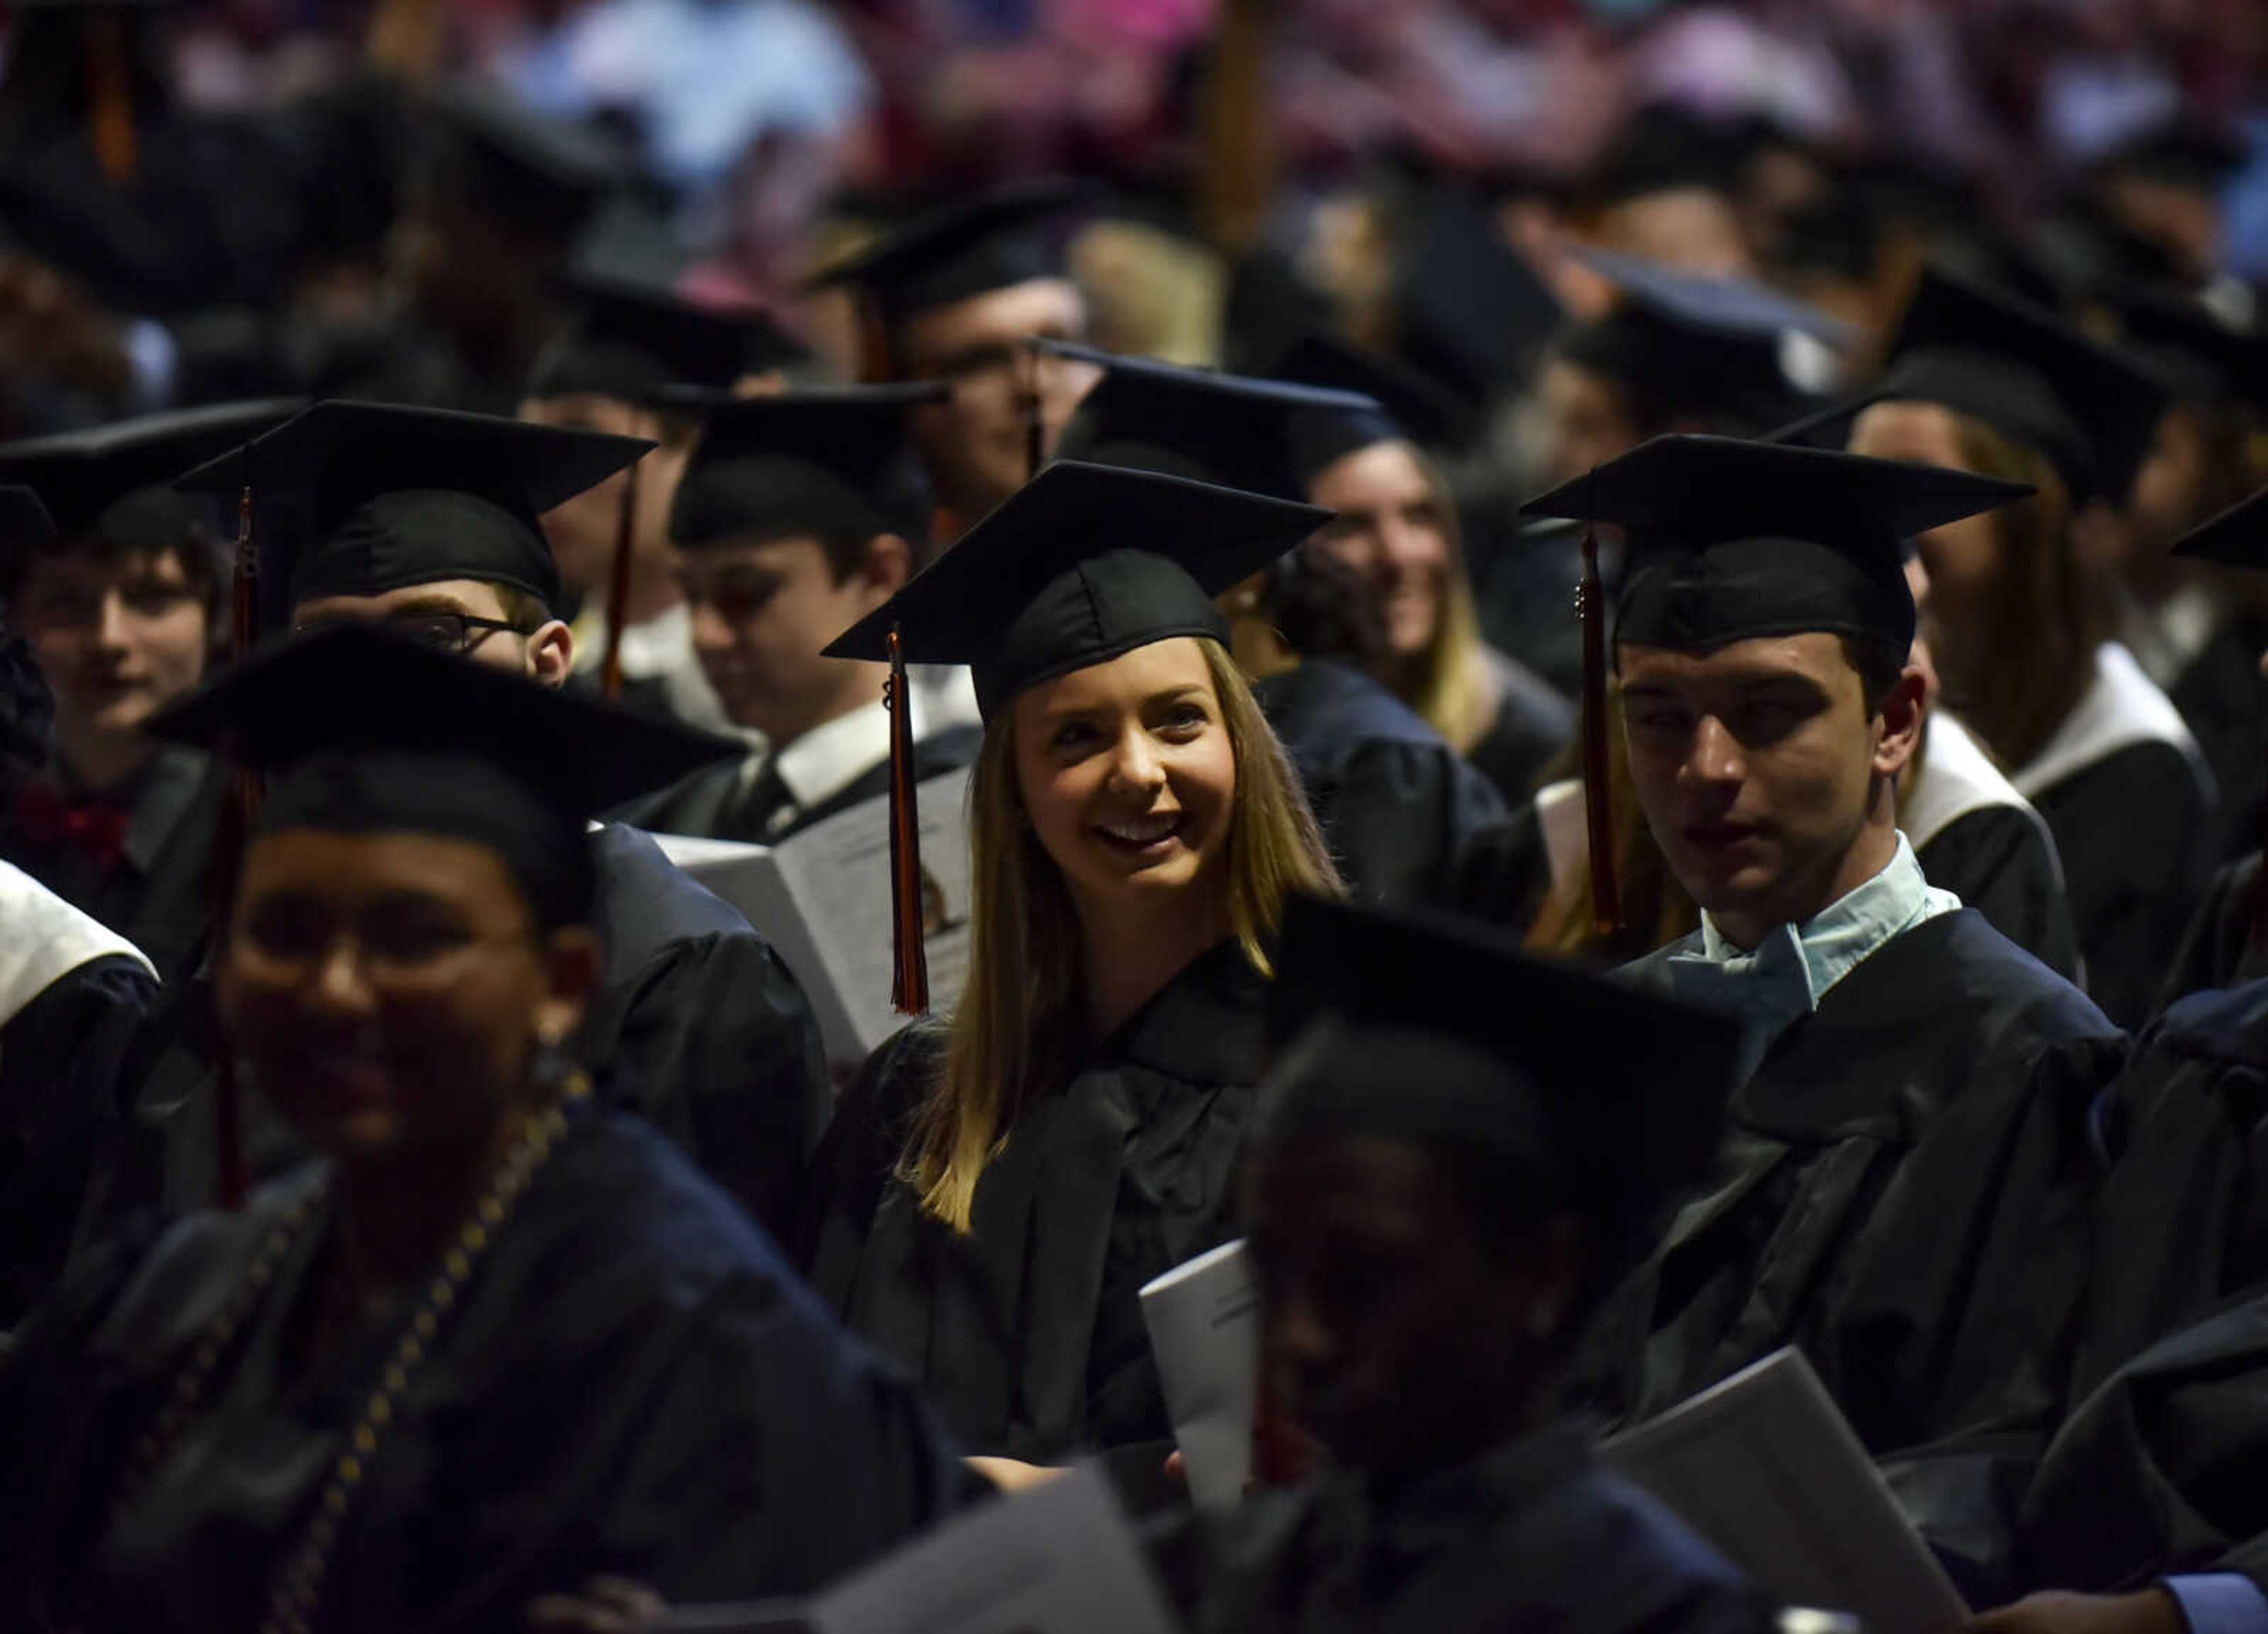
[{"left": 1045, "top": 347, "right": 1524, "bottom": 902}]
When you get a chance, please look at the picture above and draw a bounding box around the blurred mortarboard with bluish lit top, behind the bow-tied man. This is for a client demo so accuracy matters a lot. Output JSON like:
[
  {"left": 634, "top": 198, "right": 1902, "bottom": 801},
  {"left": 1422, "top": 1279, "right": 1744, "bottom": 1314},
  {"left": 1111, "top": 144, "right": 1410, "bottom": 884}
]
[{"left": 1556, "top": 249, "right": 1853, "bottom": 430}]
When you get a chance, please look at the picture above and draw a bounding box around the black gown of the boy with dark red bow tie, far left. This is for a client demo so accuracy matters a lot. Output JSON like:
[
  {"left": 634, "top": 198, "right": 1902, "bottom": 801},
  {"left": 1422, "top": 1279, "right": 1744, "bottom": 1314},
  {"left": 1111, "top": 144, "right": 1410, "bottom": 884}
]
[{"left": 0, "top": 746, "right": 227, "bottom": 981}]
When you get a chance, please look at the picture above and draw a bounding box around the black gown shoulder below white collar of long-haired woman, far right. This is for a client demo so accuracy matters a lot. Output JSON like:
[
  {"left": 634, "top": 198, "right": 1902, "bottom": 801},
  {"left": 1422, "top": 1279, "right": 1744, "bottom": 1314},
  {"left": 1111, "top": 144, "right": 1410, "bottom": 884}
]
[{"left": 2032, "top": 741, "right": 2218, "bottom": 1026}]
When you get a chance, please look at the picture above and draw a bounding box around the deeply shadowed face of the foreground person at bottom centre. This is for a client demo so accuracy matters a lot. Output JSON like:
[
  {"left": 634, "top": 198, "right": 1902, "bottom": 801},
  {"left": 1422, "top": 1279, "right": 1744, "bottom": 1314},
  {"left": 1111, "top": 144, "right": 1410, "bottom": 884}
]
[{"left": 1245, "top": 1133, "right": 1563, "bottom": 1475}]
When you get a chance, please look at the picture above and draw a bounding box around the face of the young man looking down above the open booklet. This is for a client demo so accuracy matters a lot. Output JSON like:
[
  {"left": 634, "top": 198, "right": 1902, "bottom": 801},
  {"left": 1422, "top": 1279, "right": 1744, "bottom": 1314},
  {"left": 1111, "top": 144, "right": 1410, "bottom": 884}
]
[{"left": 678, "top": 537, "right": 905, "bottom": 748}]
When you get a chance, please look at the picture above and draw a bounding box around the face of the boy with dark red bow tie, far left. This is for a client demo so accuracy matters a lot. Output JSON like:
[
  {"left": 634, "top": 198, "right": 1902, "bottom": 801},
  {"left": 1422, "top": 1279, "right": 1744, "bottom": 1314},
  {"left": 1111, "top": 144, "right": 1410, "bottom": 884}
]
[{"left": 14, "top": 551, "right": 211, "bottom": 746}]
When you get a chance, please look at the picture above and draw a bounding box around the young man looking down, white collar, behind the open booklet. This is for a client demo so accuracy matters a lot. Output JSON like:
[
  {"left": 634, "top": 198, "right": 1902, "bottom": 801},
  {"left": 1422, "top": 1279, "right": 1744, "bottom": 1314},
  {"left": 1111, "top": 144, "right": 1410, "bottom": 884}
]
[{"left": 624, "top": 385, "right": 985, "bottom": 845}]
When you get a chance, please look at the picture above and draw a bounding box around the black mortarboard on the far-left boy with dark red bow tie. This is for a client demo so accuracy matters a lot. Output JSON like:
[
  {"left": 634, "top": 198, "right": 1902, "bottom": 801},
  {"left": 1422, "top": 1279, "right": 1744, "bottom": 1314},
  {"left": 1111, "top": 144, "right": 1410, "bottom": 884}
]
[{"left": 0, "top": 397, "right": 302, "bottom": 546}]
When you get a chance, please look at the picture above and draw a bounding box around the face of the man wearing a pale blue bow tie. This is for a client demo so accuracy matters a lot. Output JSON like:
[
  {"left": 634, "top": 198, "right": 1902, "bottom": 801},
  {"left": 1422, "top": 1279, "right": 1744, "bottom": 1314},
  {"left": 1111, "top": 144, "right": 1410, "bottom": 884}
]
[{"left": 1619, "top": 632, "right": 1905, "bottom": 929}]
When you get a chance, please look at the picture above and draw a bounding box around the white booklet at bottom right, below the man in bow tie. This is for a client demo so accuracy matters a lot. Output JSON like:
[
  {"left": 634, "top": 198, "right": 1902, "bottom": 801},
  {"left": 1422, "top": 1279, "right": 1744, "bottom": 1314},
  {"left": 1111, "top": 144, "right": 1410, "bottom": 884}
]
[{"left": 1601, "top": 1348, "right": 1969, "bottom": 1634}]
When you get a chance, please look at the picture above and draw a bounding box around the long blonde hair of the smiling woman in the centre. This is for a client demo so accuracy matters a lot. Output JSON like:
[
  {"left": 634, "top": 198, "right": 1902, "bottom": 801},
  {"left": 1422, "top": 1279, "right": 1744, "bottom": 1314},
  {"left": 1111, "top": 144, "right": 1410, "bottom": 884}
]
[{"left": 898, "top": 639, "right": 1340, "bottom": 1231}]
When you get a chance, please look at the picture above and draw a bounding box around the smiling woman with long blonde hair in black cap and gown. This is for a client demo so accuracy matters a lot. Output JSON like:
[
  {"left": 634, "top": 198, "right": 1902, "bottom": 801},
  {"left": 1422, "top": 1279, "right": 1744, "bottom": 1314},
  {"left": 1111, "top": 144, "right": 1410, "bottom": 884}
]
[{"left": 799, "top": 462, "right": 1338, "bottom": 1469}]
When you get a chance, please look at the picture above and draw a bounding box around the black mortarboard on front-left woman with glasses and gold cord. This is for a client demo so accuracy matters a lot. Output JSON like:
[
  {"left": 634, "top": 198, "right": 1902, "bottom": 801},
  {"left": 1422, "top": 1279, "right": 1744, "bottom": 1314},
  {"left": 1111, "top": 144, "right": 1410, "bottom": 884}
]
[{"left": 145, "top": 623, "right": 742, "bottom": 922}]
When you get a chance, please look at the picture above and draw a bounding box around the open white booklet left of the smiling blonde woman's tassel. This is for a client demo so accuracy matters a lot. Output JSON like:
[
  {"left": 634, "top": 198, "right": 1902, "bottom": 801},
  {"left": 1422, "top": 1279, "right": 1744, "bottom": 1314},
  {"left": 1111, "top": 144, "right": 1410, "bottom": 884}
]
[{"left": 653, "top": 771, "right": 969, "bottom": 1068}]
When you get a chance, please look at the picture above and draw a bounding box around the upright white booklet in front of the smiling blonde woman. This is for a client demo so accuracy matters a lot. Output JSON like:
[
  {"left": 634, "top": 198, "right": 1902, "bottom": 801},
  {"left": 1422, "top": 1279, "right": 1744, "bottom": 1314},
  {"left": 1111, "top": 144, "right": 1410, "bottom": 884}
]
[{"left": 1141, "top": 1242, "right": 1261, "bottom": 1509}]
